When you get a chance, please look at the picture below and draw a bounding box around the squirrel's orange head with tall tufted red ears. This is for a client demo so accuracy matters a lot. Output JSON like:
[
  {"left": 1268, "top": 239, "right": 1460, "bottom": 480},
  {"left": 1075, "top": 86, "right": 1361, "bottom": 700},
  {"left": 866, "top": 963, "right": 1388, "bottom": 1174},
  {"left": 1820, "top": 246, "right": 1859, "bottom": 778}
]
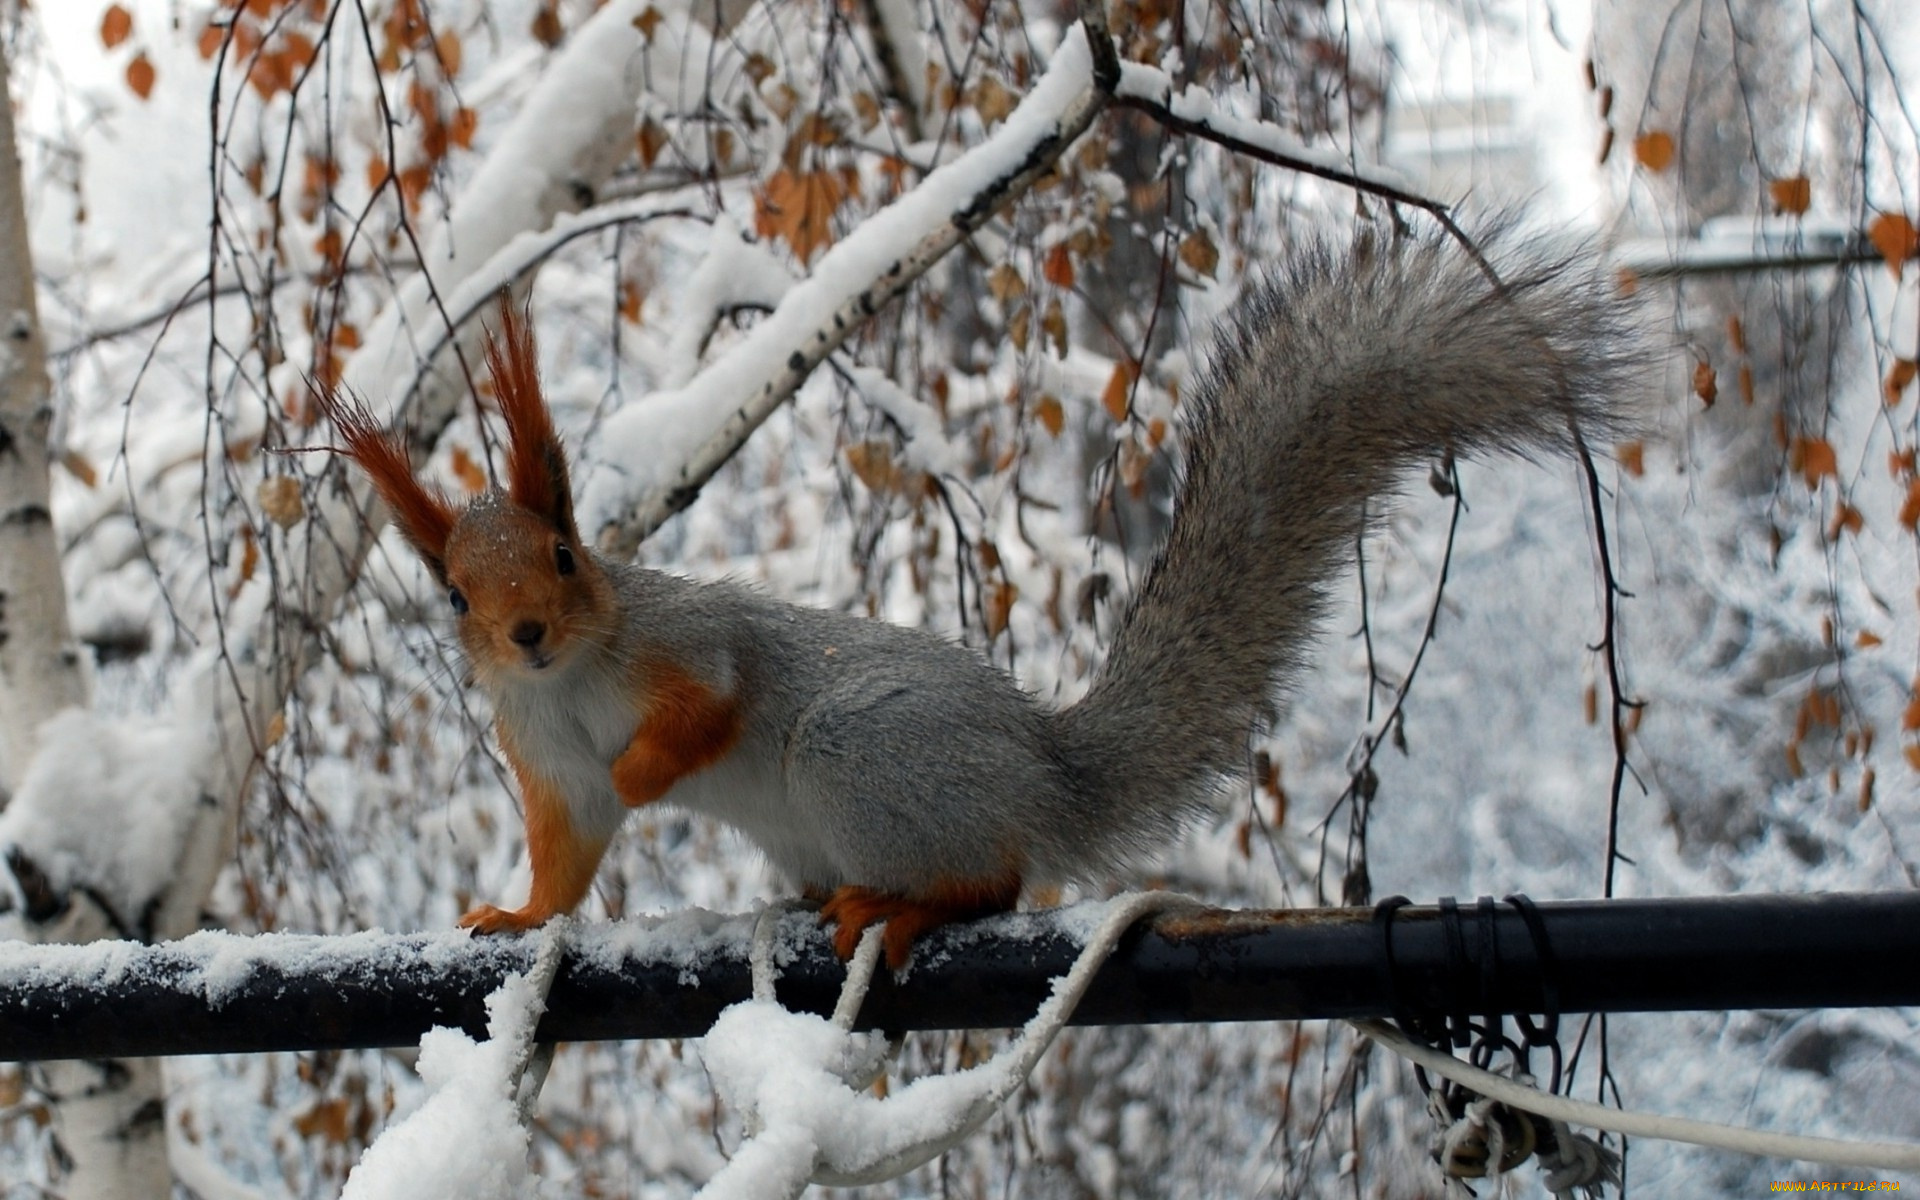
[{"left": 321, "top": 301, "right": 616, "bottom": 684}]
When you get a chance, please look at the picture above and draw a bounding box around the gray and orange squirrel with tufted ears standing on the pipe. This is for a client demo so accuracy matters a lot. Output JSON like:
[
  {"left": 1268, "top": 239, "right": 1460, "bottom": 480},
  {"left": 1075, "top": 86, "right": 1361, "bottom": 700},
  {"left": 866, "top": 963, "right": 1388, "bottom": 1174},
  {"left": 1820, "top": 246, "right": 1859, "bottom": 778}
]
[{"left": 321, "top": 230, "right": 1634, "bottom": 968}]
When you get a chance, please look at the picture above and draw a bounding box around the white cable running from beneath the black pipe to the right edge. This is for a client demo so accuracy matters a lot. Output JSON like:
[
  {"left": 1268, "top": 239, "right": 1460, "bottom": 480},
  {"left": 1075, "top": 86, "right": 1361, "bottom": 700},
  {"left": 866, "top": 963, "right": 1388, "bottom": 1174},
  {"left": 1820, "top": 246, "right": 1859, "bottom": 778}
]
[{"left": 1350, "top": 1021, "right": 1920, "bottom": 1171}]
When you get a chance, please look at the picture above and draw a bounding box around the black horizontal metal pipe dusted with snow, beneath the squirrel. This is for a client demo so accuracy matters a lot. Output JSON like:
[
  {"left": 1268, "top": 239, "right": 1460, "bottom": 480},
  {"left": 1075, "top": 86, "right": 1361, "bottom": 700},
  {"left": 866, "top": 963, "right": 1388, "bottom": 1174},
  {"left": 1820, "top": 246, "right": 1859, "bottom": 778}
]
[{"left": 0, "top": 893, "right": 1920, "bottom": 1060}]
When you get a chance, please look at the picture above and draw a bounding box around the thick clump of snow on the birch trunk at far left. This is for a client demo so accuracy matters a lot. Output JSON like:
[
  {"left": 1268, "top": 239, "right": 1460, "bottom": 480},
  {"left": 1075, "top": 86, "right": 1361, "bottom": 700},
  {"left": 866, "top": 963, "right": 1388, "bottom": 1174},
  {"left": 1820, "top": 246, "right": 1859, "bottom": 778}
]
[{"left": 0, "top": 708, "right": 213, "bottom": 925}]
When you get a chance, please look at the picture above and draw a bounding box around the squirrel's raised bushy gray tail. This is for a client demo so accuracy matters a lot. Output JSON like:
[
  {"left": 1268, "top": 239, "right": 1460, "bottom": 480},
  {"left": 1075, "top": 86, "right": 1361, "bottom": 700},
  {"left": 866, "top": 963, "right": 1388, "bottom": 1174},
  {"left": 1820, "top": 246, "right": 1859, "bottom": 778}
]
[{"left": 1056, "top": 222, "right": 1644, "bottom": 858}]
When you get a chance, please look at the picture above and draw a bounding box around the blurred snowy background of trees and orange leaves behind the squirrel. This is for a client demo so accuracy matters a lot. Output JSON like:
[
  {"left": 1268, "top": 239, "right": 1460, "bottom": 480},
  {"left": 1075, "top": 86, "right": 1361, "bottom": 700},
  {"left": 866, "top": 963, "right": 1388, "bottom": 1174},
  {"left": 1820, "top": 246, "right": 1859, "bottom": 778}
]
[{"left": 0, "top": 0, "right": 1920, "bottom": 1198}]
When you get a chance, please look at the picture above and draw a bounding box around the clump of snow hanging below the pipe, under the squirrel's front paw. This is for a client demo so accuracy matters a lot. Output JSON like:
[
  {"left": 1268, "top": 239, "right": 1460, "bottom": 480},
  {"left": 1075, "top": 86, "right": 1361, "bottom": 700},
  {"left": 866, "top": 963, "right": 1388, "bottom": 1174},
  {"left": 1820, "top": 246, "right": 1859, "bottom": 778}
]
[{"left": 340, "top": 963, "right": 545, "bottom": 1200}]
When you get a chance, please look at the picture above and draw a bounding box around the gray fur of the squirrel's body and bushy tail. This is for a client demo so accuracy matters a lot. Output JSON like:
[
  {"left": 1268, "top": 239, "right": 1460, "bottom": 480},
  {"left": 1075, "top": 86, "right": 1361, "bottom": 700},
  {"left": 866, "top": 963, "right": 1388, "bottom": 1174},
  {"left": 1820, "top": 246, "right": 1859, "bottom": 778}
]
[{"left": 495, "top": 224, "right": 1634, "bottom": 895}]
